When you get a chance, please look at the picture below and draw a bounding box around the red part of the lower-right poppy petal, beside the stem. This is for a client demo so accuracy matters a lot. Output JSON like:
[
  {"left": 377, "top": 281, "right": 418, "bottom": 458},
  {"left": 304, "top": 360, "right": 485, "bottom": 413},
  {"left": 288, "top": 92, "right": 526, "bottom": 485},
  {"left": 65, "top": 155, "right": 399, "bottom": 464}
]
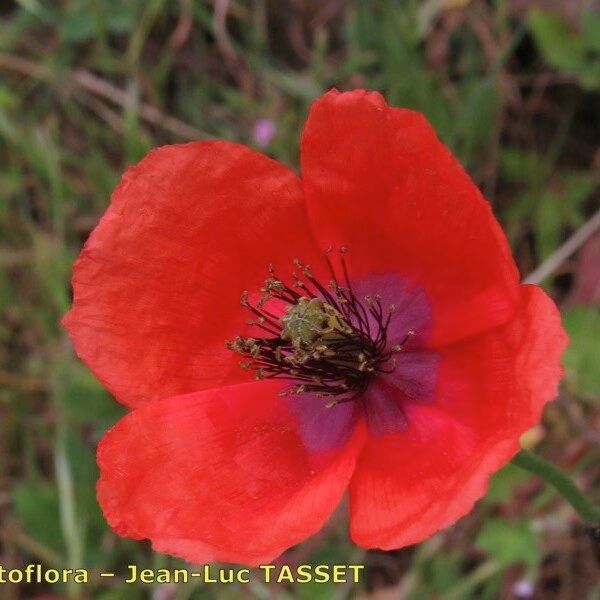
[{"left": 350, "top": 286, "right": 567, "bottom": 549}]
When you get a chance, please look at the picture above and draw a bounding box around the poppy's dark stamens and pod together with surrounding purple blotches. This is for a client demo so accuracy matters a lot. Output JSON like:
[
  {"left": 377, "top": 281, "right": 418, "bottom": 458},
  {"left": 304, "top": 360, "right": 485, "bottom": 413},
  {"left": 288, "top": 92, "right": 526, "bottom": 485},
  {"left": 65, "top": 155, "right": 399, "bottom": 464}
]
[{"left": 227, "top": 247, "right": 438, "bottom": 451}]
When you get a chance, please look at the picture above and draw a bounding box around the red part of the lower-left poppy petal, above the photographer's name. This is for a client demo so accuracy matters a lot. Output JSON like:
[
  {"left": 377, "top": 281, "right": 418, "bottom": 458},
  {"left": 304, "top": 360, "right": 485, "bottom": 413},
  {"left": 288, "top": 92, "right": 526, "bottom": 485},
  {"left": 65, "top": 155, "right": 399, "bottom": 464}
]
[{"left": 98, "top": 381, "right": 364, "bottom": 565}]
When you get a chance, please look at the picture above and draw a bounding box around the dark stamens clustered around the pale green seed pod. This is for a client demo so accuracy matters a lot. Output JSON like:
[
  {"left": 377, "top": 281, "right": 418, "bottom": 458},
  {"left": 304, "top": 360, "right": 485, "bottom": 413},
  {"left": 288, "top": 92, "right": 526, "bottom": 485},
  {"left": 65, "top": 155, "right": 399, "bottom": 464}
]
[{"left": 227, "top": 247, "right": 414, "bottom": 406}]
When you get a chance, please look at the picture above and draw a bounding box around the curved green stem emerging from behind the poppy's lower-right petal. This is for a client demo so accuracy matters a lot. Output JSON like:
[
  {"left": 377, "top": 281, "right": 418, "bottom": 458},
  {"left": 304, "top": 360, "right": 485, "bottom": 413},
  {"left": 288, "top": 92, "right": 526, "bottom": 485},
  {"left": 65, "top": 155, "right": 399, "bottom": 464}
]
[{"left": 512, "top": 449, "right": 600, "bottom": 523}]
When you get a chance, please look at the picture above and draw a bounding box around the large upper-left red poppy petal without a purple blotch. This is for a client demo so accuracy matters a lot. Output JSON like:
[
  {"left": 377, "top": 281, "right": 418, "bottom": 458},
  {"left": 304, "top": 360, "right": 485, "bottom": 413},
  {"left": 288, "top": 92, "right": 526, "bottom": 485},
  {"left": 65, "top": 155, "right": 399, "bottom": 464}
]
[{"left": 64, "top": 142, "right": 322, "bottom": 406}]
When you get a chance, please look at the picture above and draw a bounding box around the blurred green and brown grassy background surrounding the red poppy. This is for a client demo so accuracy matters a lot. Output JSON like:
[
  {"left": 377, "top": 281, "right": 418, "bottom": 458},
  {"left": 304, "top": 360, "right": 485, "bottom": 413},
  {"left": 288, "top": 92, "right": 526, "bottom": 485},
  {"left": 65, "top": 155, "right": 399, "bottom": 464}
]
[{"left": 0, "top": 0, "right": 600, "bottom": 600}]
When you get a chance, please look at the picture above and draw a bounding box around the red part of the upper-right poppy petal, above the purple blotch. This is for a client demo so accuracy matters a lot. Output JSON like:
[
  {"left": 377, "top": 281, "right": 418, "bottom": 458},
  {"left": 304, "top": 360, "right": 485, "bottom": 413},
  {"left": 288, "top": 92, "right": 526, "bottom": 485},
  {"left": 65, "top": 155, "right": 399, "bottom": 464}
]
[{"left": 301, "top": 90, "right": 519, "bottom": 345}]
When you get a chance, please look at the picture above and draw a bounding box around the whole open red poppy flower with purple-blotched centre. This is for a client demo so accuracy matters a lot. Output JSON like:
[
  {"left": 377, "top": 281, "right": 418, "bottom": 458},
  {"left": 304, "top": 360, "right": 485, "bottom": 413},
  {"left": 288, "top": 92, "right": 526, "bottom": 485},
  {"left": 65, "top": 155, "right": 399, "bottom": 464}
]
[{"left": 65, "top": 91, "right": 566, "bottom": 564}]
